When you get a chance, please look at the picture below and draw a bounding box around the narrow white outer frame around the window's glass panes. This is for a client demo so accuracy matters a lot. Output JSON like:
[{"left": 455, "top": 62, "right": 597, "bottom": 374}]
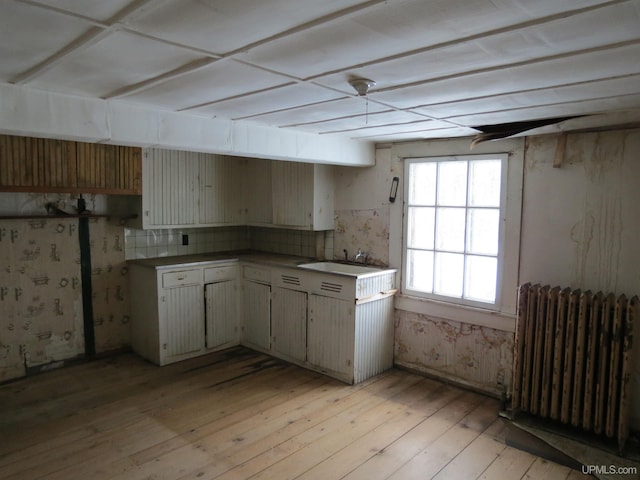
[{"left": 402, "top": 153, "right": 508, "bottom": 311}]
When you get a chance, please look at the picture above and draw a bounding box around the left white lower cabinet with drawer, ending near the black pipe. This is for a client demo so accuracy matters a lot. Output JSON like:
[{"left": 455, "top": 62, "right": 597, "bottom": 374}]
[{"left": 130, "top": 263, "right": 239, "bottom": 365}]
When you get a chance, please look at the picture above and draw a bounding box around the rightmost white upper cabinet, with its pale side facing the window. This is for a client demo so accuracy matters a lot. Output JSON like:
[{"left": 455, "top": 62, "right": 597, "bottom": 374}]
[{"left": 271, "top": 161, "right": 334, "bottom": 230}]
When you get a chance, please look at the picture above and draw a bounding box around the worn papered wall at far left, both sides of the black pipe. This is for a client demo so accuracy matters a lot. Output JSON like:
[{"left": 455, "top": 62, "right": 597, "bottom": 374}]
[{"left": 0, "top": 193, "right": 130, "bottom": 382}]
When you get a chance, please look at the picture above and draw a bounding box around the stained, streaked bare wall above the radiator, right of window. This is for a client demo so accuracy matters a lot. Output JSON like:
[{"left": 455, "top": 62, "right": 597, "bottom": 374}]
[{"left": 520, "top": 129, "right": 640, "bottom": 429}]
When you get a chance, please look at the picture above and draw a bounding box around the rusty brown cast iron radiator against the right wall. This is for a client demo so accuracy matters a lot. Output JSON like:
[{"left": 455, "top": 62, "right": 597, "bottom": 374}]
[{"left": 512, "top": 283, "right": 640, "bottom": 450}]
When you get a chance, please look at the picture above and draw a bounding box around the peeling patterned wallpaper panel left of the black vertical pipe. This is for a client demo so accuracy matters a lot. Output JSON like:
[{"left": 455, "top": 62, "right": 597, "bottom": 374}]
[{"left": 0, "top": 219, "right": 84, "bottom": 380}]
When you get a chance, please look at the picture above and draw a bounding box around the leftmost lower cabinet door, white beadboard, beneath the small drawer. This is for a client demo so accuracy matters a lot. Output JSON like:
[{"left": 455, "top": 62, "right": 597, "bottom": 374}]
[{"left": 160, "top": 284, "right": 204, "bottom": 357}]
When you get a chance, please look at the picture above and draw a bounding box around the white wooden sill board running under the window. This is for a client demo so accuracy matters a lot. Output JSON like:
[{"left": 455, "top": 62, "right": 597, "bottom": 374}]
[{"left": 395, "top": 294, "right": 516, "bottom": 333}]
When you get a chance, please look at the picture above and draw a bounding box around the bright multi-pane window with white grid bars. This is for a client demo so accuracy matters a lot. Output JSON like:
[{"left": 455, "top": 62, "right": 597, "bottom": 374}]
[{"left": 403, "top": 154, "right": 507, "bottom": 308}]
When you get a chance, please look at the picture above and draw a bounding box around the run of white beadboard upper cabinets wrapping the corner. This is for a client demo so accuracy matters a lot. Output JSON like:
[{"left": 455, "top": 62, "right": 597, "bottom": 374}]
[{"left": 124, "top": 148, "right": 334, "bottom": 230}]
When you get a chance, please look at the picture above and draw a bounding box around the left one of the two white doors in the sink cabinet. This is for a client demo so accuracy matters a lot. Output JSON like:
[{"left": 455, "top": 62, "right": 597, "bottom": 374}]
[{"left": 271, "top": 287, "right": 307, "bottom": 361}]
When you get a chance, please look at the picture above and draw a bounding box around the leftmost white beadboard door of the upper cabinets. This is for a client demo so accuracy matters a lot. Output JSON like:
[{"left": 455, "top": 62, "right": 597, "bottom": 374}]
[{"left": 142, "top": 148, "right": 200, "bottom": 228}]
